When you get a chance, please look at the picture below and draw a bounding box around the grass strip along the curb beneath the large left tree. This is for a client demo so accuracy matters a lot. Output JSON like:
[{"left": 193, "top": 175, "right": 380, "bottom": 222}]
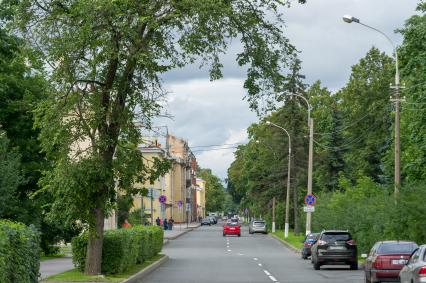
[{"left": 43, "top": 255, "right": 164, "bottom": 282}]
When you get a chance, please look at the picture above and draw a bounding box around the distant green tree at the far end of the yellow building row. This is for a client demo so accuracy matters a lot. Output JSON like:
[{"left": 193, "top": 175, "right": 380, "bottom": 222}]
[{"left": 198, "top": 169, "right": 225, "bottom": 211}]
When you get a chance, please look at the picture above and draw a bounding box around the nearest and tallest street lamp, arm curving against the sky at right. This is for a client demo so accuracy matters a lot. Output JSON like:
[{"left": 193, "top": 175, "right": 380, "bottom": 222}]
[{"left": 343, "top": 15, "right": 402, "bottom": 196}]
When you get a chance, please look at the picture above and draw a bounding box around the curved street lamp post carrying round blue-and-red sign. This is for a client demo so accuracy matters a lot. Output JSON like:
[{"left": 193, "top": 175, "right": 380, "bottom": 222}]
[{"left": 289, "top": 93, "right": 314, "bottom": 235}]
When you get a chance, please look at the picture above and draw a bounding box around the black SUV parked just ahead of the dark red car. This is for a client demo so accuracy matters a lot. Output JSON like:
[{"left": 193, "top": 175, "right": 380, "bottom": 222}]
[{"left": 311, "top": 230, "right": 358, "bottom": 270}]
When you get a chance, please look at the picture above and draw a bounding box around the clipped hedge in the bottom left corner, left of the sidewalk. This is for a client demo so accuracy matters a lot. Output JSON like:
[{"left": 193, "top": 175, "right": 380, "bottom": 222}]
[{"left": 0, "top": 220, "right": 40, "bottom": 283}]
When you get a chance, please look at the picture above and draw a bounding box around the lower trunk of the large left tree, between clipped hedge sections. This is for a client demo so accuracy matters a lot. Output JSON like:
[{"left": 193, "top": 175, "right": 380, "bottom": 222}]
[{"left": 84, "top": 208, "right": 105, "bottom": 275}]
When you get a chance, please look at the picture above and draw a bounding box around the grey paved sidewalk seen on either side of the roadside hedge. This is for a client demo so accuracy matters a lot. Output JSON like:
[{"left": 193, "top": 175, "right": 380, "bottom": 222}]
[{"left": 39, "top": 222, "right": 200, "bottom": 280}]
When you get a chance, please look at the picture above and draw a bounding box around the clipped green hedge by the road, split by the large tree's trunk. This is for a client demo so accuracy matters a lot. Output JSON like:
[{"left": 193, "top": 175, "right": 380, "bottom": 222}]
[{"left": 72, "top": 226, "right": 163, "bottom": 274}]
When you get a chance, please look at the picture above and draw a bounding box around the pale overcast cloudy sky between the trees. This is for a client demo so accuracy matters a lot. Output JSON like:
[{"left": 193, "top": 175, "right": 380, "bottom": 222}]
[{"left": 158, "top": 0, "right": 419, "bottom": 178}]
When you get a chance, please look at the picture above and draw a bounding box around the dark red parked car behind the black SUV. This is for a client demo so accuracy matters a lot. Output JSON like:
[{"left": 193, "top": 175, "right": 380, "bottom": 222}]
[{"left": 365, "top": 241, "right": 418, "bottom": 283}]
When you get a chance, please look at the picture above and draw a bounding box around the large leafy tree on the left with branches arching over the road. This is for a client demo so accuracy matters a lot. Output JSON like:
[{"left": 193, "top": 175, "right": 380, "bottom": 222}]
[{"left": 1, "top": 0, "right": 303, "bottom": 274}]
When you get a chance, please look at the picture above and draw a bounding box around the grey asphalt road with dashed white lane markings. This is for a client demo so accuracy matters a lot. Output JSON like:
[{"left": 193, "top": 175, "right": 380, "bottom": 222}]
[{"left": 143, "top": 225, "right": 364, "bottom": 283}]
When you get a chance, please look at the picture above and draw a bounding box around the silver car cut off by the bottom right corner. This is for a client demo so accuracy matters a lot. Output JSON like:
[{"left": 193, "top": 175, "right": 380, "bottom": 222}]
[{"left": 399, "top": 245, "right": 426, "bottom": 283}]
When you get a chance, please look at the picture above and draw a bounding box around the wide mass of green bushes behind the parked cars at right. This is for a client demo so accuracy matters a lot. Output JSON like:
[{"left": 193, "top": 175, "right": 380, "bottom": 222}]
[{"left": 313, "top": 178, "right": 426, "bottom": 253}]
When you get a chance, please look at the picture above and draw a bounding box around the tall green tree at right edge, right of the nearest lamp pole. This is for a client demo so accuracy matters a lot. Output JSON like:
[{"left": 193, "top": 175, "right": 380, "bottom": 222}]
[{"left": 398, "top": 5, "right": 426, "bottom": 182}]
